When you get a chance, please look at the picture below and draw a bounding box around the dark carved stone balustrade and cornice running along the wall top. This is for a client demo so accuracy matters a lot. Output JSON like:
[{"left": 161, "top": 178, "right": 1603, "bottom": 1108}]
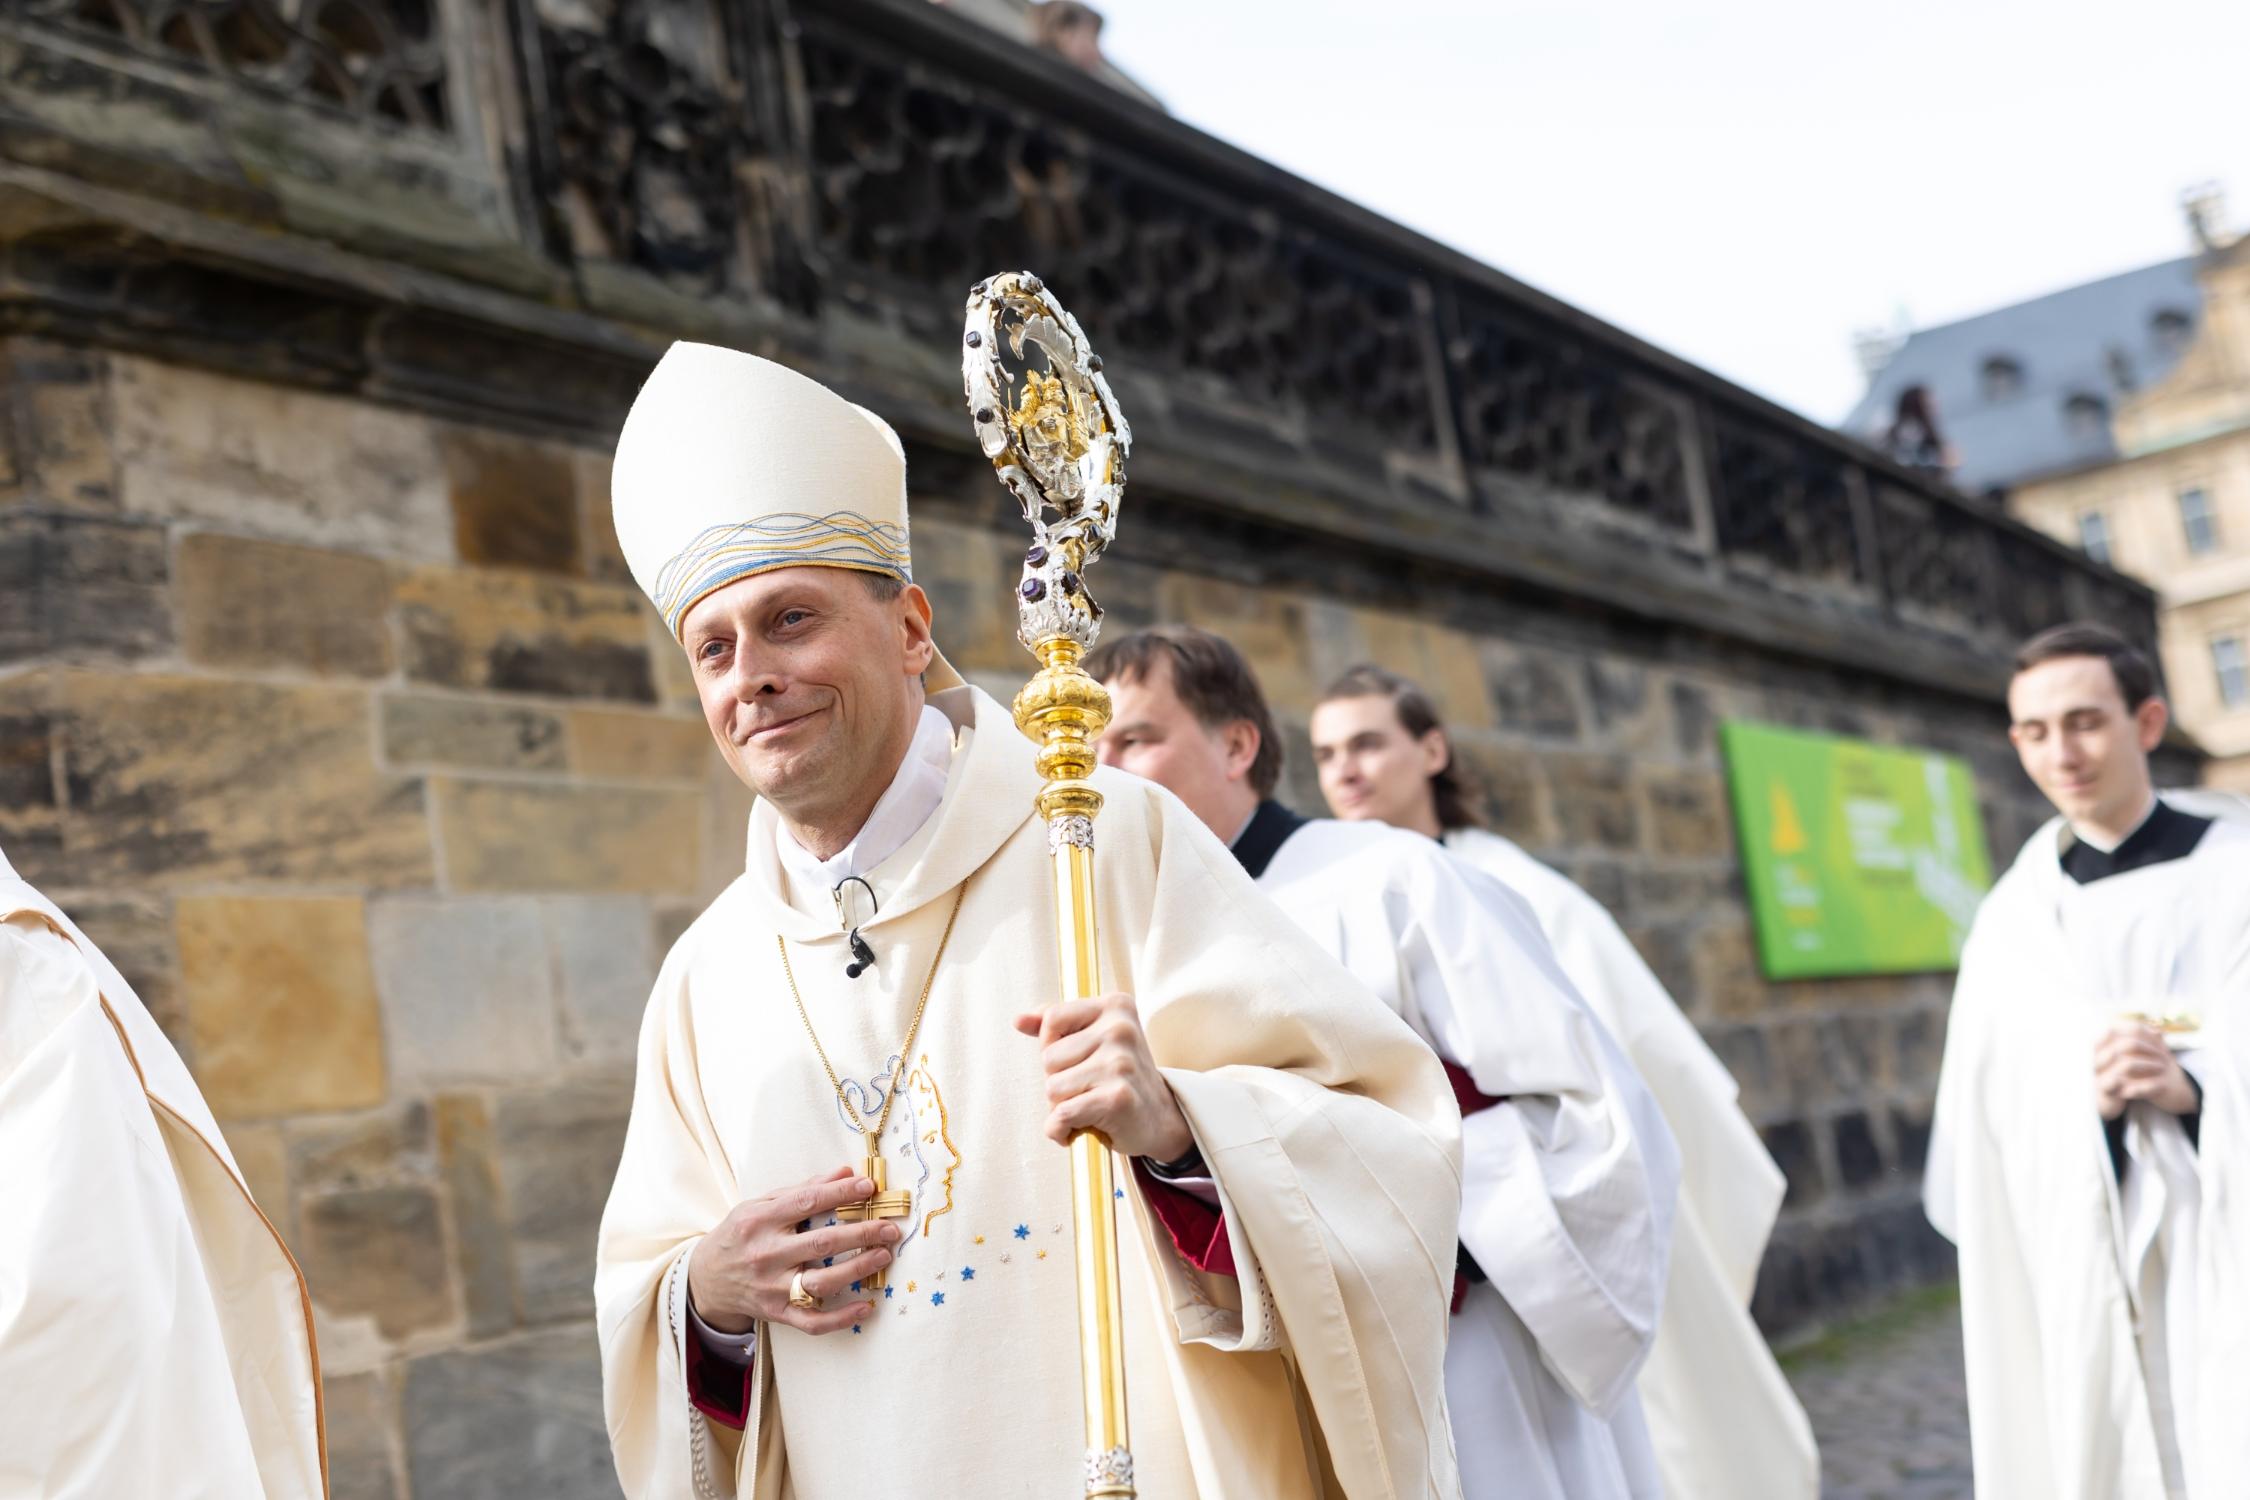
[{"left": 0, "top": 0, "right": 2156, "bottom": 697}]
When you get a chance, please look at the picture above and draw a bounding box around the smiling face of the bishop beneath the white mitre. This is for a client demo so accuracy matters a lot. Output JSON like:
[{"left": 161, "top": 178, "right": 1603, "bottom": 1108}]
[{"left": 680, "top": 567, "right": 936, "bottom": 848}]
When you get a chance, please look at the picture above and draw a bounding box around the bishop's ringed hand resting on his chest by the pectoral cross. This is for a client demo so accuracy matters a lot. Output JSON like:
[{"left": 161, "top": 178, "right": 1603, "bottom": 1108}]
[{"left": 689, "top": 1167, "right": 900, "bottom": 1334}]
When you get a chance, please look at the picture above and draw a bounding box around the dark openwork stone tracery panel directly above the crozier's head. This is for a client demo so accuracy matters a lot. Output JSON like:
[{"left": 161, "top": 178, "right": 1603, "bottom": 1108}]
[{"left": 801, "top": 29, "right": 1436, "bottom": 452}]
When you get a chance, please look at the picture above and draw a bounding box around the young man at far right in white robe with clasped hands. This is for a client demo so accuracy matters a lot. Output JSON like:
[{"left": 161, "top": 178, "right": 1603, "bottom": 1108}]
[{"left": 1924, "top": 625, "right": 2250, "bottom": 1500}]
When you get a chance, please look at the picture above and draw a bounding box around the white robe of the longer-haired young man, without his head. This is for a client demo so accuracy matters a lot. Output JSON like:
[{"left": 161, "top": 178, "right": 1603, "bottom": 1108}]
[{"left": 1445, "top": 828, "right": 1820, "bottom": 1500}]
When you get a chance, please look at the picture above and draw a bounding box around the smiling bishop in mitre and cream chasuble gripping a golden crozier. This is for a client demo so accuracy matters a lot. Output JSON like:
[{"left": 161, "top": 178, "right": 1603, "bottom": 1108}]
[{"left": 596, "top": 344, "right": 1460, "bottom": 1500}]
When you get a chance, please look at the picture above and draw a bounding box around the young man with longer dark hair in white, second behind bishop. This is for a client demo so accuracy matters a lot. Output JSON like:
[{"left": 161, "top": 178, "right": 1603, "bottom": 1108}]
[{"left": 1312, "top": 663, "right": 1820, "bottom": 1500}]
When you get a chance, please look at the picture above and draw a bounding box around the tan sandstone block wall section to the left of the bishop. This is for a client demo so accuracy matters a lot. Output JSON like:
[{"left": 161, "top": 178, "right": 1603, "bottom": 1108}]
[{"left": 0, "top": 340, "right": 747, "bottom": 1500}]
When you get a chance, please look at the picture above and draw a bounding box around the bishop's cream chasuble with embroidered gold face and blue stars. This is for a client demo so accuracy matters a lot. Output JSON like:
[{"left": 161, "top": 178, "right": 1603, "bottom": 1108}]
[{"left": 594, "top": 688, "right": 1460, "bottom": 1500}]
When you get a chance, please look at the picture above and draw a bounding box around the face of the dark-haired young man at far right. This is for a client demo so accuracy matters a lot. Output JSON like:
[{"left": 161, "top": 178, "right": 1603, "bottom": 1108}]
[{"left": 2007, "top": 657, "right": 2165, "bottom": 837}]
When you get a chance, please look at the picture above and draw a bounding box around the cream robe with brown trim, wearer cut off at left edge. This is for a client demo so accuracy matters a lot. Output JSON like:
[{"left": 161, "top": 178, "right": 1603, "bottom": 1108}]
[{"left": 0, "top": 859, "right": 326, "bottom": 1500}]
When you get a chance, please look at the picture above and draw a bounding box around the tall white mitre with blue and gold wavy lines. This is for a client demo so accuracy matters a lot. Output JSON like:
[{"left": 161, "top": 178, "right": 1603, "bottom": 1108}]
[{"left": 610, "top": 344, "right": 914, "bottom": 639}]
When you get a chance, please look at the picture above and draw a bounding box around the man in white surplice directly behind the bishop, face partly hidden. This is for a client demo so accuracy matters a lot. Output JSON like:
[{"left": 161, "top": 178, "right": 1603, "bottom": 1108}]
[{"left": 1087, "top": 627, "right": 1679, "bottom": 1500}]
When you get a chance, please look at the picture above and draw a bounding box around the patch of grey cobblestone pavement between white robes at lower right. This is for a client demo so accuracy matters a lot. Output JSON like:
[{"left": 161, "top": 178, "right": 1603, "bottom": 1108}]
[{"left": 1784, "top": 1289, "right": 1973, "bottom": 1500}]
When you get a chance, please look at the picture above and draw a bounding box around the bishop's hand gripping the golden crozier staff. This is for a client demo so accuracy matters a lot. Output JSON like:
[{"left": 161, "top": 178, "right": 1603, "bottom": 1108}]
[{"left": 1015, "top": 994, "right": 1195, "bottom": 1160}]
